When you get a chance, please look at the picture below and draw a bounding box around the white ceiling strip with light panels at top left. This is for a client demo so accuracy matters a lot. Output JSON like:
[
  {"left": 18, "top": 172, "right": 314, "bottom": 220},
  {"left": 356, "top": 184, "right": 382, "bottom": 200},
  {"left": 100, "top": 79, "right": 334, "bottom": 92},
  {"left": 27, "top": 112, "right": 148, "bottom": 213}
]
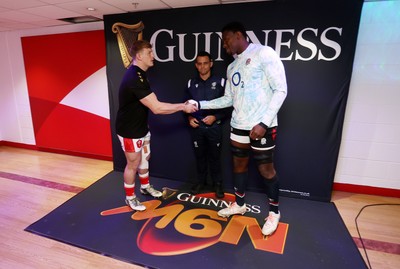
[{"left": 0, "top": 0, "right": 263, "bottom": 32}]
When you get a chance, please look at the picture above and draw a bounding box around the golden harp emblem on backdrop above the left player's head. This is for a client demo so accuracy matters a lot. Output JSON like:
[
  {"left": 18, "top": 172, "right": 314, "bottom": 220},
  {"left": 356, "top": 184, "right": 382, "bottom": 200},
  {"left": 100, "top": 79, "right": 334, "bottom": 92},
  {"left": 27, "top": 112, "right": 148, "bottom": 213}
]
[{"left": 112, "top": 21, "right": 144, "bottom": 68}]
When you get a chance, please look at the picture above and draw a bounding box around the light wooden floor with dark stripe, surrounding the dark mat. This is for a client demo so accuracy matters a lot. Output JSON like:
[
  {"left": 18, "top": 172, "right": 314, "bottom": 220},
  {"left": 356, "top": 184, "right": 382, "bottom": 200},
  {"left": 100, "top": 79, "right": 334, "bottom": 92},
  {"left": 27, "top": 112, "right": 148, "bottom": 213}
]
[{"left": 0, "top": 146, "right": 400, "bottom": 269}]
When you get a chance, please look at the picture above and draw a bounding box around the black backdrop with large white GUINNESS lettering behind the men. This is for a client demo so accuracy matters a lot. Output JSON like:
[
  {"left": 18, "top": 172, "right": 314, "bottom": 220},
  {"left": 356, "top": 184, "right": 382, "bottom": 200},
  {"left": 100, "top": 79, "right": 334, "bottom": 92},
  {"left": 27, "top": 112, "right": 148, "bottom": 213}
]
[{"left": 104, "top": 0, "right": 363, "bottom": 201}]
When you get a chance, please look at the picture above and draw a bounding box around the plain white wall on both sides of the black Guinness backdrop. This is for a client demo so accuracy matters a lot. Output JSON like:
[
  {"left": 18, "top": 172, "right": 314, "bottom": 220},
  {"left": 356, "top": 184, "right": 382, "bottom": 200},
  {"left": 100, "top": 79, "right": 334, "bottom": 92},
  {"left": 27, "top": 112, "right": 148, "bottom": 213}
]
[{"left": 0, "top": 0, "right": 400, "bottom": 189}]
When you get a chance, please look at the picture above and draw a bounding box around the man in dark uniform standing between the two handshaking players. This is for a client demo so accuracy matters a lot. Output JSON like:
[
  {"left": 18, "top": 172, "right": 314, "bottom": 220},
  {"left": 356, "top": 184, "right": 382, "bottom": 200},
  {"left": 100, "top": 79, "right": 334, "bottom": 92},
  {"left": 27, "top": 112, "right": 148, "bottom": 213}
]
[{"left": 187, "top": 51, "right": 231, "bottom": 198}]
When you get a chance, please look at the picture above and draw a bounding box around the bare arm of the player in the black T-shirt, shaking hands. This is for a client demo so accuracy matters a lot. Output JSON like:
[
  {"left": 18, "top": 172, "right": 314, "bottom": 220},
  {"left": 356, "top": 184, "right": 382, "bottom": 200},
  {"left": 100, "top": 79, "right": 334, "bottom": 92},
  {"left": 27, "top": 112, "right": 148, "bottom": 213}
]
[{"left": 140, "top": 93, "right": 197, "bottom": 114}]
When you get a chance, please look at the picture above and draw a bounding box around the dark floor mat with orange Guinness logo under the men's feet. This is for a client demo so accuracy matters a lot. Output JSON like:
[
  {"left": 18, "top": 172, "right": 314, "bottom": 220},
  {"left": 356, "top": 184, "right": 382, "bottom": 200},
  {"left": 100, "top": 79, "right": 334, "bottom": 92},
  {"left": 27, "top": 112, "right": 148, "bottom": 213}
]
[{"left": 25, "top": 171, "right": 367, "bottom": 269}]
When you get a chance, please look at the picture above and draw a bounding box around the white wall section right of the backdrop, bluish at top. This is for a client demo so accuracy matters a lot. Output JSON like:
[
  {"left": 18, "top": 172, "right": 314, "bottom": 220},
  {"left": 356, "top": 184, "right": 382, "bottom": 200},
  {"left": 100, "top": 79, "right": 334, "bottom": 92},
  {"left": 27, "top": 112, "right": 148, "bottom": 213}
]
[{"left": 335, "top": 1, "right": 400, "bottom": 189}]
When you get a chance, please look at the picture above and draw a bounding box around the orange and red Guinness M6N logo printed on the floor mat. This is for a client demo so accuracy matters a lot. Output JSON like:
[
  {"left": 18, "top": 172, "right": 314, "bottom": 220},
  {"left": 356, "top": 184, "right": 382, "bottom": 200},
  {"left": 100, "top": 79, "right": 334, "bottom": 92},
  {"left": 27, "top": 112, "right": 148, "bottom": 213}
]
[{"left": 100, "top": 187, "right": 289, "bottom": 253}]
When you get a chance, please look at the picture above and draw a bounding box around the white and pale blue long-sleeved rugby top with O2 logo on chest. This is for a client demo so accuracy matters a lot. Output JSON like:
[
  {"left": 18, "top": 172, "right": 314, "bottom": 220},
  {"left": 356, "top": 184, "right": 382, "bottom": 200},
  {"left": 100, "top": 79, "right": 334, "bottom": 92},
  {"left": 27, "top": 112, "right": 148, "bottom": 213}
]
[{"left": 200, "top": 43, "right": 287, "bottom": 130}]
